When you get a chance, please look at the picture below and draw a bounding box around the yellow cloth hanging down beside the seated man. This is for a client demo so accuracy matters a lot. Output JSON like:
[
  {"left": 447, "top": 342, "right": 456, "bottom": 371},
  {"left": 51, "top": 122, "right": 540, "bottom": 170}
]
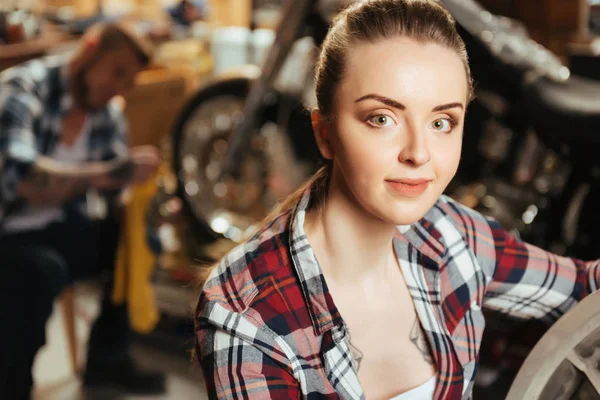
[{"left": 112, "top": 179, "right": 159, "bottom": 333}]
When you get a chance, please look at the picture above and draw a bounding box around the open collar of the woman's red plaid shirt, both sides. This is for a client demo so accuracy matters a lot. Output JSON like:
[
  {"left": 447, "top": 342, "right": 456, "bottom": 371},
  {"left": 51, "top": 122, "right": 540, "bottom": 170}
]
[{"left": 289, "top": 187, "right": 446, "bottom": 336}]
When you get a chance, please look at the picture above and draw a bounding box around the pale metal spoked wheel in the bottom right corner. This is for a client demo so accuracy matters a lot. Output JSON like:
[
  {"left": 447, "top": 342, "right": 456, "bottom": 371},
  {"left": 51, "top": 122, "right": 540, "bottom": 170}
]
[{"left": 507, "top": 292, "right": 600, "bottom": 400}]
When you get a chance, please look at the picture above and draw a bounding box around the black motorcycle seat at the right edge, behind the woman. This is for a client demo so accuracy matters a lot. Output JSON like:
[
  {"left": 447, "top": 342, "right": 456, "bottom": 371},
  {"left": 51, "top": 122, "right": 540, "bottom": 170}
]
[{"left": 525, "top": 76, "right": 600, "bottom": 145}]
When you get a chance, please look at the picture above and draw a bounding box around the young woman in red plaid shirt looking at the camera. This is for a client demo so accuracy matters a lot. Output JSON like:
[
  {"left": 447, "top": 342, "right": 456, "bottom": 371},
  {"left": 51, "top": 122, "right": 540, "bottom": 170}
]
[{"left": 196, "top": 0, "right": 600, "bottom": 399}]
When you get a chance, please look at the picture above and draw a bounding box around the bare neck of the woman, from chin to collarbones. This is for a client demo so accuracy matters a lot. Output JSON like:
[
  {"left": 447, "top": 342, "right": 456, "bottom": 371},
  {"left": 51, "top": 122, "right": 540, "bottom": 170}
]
[{"left": 304, "top": 173, "right": 397, "bottom": 284}]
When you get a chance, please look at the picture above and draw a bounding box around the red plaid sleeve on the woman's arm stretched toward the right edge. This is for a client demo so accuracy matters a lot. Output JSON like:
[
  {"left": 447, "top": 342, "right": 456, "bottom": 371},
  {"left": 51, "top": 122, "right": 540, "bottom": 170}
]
[{"left": 486, "top": 221, "right": 600, "bottom": 321}]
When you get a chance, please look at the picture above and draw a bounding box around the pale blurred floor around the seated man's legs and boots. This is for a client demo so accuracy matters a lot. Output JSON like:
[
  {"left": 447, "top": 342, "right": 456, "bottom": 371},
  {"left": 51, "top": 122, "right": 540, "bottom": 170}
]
[{"left": 34, "top": 289, "right": 208, "bottom": 400}]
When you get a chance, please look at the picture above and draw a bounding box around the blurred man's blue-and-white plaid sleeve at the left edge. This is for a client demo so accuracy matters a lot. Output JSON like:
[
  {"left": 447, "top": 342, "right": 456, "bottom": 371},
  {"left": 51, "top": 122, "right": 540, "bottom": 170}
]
[{"left": 0, "top": 85, "right": 42, "bottom": 205}]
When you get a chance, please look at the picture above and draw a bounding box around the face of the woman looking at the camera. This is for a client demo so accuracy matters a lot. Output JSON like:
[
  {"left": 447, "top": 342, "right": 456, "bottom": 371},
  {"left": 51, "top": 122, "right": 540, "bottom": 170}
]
[{"left": 317, "top": 37, "right": 468, "bottom": 225}]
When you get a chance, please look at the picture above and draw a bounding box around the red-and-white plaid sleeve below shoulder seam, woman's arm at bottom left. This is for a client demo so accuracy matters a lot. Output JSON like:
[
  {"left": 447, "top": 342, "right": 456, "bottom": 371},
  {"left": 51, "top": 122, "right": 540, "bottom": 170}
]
[{"left": 196, "top": 314, "right": 300, "bottom": 400}]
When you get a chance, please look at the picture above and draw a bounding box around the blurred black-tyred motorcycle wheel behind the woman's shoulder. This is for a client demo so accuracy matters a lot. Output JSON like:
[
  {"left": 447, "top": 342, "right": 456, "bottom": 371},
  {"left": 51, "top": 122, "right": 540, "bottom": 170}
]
[{"left": 173, "top": 79, "right": 314, "bottom": 242}]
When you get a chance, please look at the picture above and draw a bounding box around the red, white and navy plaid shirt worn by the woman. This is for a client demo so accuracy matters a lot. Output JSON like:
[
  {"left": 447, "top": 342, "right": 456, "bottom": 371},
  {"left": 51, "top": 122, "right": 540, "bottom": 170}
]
[{"left": 196, "top": 188, "right": 600, "bottom": 399}]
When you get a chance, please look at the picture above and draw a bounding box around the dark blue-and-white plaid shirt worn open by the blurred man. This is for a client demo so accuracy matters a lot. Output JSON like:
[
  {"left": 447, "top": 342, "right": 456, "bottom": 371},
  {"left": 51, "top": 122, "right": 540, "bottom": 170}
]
[{"left": 0, "top": 56, "right": 127, "bottom": 221}]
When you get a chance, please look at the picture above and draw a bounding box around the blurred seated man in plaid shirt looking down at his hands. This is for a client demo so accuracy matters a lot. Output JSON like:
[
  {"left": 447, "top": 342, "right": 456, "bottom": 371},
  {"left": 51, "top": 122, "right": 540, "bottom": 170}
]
[{"left": 0, "top": 24, "right": 164, "bottom": 399}]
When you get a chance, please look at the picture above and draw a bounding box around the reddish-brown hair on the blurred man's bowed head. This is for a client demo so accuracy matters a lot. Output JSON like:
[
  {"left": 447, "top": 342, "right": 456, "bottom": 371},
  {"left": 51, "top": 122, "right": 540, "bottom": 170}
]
[{"left": 85, "top": 22, "right": 153, "bottom": 66}]
